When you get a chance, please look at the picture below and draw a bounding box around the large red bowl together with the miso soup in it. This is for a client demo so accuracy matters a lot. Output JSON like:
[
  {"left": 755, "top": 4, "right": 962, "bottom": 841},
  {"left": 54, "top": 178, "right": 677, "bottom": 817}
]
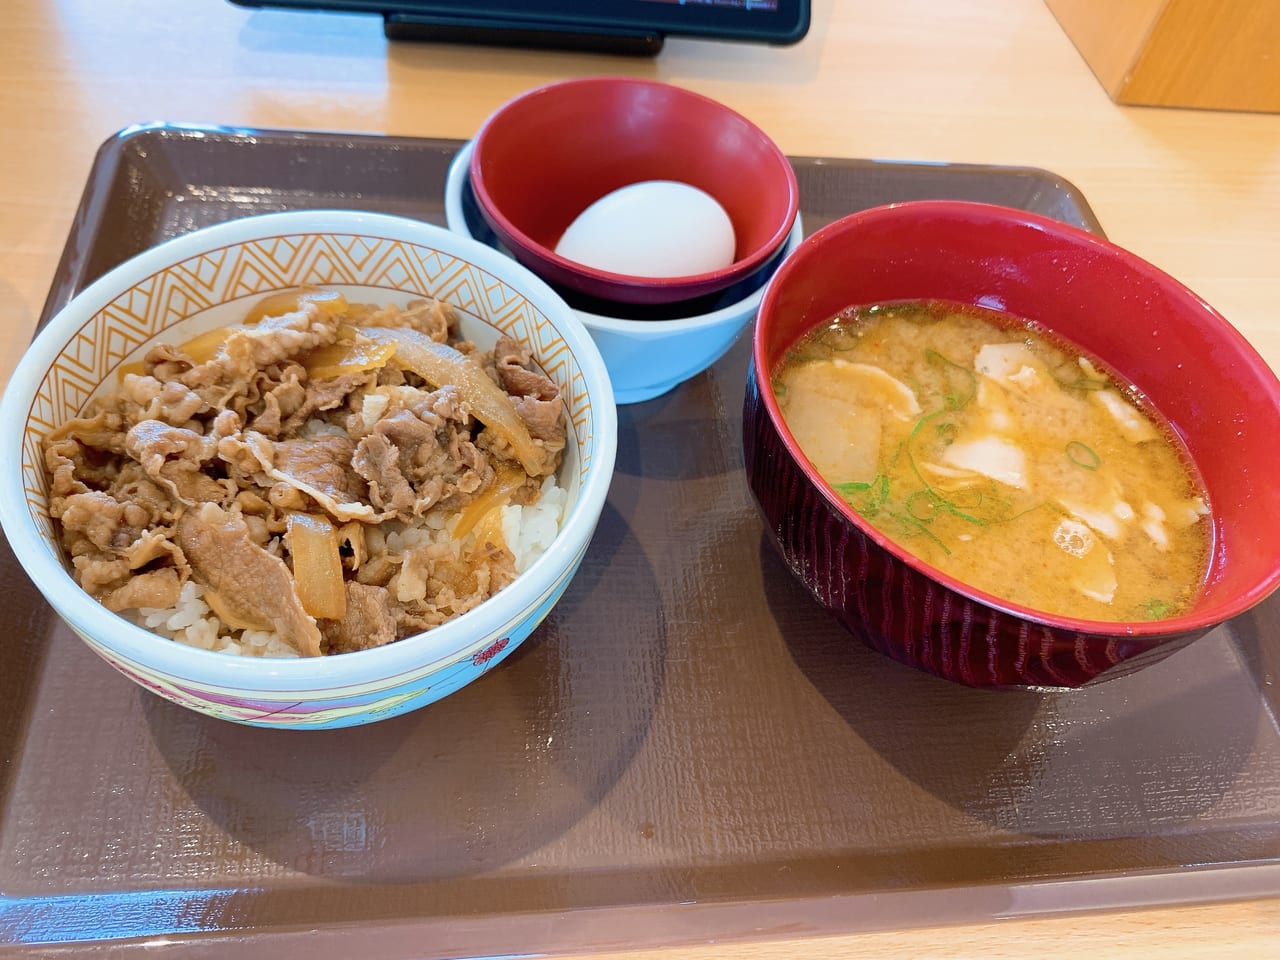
[{"left": 744, "top": 201, "right": 1280, "bottom": 687}]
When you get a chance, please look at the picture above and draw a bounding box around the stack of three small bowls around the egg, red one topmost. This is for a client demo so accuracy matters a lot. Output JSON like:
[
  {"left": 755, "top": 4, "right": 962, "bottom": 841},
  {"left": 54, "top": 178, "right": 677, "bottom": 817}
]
[{"left": 445, "top": 77, "right": 804, "bottom": 403}]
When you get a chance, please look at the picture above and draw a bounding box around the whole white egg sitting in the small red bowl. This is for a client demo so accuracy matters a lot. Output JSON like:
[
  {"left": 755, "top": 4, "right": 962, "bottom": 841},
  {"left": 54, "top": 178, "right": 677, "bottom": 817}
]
[{"left": 556, "top": 180, "right": 736, "bottom": 276}]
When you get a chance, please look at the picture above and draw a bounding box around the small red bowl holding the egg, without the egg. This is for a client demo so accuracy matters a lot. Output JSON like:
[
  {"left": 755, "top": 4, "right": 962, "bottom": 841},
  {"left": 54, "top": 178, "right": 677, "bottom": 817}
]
[{"left": 471, "top": 77, "right": 800, "bottom": 303}]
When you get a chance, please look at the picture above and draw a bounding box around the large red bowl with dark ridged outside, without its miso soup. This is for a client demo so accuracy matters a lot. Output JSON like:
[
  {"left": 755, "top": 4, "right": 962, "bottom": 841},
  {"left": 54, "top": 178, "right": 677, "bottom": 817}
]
[{"left": 744, "top": 201, "right": 1280, "bottom": 687}]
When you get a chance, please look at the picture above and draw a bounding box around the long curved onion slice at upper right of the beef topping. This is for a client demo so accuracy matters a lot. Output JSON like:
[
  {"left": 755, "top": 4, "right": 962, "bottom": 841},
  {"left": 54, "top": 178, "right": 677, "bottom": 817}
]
[{"left": 360, "top": 326, "right": 548, "bottom": 476}]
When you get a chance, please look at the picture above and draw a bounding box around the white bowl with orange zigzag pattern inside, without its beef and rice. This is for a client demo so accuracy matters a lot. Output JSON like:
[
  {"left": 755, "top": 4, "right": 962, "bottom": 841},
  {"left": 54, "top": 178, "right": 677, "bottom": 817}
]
[{"left": 0, "top": 211, "right": 617, "bottom": 727}]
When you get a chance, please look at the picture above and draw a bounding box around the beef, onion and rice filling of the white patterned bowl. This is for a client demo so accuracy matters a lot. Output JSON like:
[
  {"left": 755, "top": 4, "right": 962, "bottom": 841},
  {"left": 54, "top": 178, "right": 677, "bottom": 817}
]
[{"left": 45, "top": 289, "right": 566, "bottom": 657}]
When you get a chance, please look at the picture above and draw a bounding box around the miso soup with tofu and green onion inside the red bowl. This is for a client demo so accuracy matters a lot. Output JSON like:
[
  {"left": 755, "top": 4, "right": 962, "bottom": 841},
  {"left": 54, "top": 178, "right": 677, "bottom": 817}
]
[{"left": 773, "top": 301, "right": 1212, "bottom": 621}]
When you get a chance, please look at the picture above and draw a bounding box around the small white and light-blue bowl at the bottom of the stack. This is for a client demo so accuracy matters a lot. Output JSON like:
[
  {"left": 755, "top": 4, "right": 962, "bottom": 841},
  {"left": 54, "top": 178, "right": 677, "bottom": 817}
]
[{"left": 444, "top": 142, "right": 804, "bottom": 403}]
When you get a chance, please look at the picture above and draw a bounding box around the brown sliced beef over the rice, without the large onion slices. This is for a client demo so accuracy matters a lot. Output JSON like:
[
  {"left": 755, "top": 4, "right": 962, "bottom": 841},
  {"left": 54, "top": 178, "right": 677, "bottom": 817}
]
[{"left": 44, "top": 289, "right": 555, "bottom": 655}]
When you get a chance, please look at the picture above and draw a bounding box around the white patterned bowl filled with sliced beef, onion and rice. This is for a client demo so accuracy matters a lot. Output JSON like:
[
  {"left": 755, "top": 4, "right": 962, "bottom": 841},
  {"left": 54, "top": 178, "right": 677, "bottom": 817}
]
[{"left": 0, "top": 211, "right": 616, "bottom": 727}]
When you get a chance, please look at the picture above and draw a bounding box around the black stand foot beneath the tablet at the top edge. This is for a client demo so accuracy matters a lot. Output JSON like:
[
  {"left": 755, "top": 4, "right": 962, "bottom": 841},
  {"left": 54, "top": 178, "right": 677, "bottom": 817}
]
[{"left": 383, "top": 13, "right": 663, "bottom": 56}]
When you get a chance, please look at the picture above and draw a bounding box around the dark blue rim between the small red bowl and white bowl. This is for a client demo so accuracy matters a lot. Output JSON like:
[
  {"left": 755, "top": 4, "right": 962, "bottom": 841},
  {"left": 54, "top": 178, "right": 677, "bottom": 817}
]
[{"left": 451, "top": 141, "right": 790, "bottom": 320}]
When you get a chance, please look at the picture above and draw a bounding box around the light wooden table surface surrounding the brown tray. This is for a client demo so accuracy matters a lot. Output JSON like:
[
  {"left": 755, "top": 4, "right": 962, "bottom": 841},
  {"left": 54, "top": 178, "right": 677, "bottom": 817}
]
[{"left": 0, "top": 0, "right": 1280, "bottom": 960}]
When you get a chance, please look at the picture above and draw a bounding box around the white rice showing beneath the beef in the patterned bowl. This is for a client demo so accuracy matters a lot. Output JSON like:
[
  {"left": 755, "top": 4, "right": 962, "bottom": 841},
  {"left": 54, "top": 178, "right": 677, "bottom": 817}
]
[{"left": 124, "top": 476, "right": 568, "bottom": 657}]
